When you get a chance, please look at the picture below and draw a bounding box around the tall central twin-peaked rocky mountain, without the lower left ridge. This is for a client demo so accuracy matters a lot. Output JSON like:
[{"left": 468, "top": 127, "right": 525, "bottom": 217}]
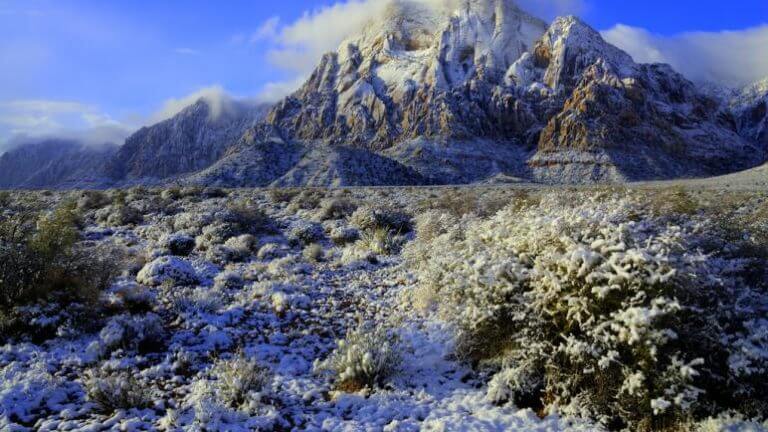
[{"left": 254, "top": 0, "right": 760, "bottom": 183}]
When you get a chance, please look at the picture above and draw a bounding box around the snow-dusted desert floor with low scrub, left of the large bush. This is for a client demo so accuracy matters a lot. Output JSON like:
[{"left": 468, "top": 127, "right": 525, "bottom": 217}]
[{"left": 0, "top": 187, "right": 768, "bottom": 431}]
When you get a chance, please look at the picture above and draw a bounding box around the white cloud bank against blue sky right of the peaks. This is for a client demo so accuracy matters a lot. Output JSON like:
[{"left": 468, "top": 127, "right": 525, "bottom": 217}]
[{"left": 603, "top": 24, "right": 768, "bottom": 86}]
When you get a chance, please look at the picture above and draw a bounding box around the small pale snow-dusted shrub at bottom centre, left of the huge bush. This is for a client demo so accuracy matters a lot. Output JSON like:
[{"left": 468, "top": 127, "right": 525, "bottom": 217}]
[{"left": 315, "top": 325, "right": 402, "bottom": 392}]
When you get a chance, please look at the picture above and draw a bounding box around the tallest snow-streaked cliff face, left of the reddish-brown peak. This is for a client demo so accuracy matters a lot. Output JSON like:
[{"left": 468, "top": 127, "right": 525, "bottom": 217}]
[{"left": 269, "top": 0, "right": 546, "bottom": 150}]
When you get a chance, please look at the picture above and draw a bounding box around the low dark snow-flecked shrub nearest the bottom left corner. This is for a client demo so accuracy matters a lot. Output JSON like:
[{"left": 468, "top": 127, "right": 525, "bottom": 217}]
[{"left": 83, "top": 369, "right": 154, "bottom": 414}]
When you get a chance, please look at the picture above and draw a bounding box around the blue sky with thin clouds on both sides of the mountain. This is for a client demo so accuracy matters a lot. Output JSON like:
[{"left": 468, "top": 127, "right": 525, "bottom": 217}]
[{"left": 0, "top": 0, "right": 768, "bottom": 151}]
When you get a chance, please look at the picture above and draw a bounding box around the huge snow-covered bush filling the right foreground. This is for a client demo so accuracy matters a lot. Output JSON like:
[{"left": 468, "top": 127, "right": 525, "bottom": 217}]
[{"left": 416, "top": 195, "right": 768, "bottom": 430}]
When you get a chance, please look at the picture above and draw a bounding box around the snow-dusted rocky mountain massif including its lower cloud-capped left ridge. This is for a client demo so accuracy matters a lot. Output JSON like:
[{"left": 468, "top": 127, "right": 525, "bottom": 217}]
[{"left": 1, "top": 0, "right": 768, "bottom": 186}]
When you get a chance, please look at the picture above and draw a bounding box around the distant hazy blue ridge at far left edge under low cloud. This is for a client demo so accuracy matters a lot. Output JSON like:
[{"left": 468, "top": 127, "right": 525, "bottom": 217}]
[{"left": 0, "top": 139, "right": 117, "bottom": 189}]
